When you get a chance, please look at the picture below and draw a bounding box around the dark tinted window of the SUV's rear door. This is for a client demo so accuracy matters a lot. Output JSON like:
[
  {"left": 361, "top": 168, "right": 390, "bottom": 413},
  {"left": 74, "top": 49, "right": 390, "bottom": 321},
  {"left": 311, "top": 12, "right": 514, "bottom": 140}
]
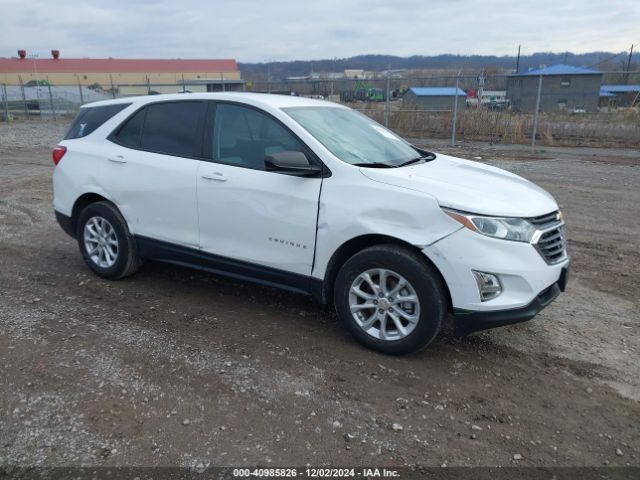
[{"left": 140, "top": 102, "right": 204, "bottom": 157}]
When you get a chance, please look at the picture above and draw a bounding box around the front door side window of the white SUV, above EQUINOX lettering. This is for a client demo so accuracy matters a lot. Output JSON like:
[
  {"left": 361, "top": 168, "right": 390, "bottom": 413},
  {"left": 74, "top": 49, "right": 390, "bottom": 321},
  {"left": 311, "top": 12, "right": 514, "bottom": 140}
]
[{"left": 213, "top": 103, "right": 303, "bottom": 170}]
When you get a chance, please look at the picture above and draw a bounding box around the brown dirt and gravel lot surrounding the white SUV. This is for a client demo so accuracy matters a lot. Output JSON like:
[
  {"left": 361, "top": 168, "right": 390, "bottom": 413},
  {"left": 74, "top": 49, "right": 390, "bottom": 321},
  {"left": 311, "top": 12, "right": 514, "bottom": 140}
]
[{"left": 0, "top": 123, "right": 640, "bottom": 467}]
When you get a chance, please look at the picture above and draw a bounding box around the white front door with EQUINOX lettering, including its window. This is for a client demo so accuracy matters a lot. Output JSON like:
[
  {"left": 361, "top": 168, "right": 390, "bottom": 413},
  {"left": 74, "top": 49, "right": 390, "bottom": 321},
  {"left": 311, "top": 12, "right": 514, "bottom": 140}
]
[{"left": 197, "top": 102, "right": 322, "bottom": 275}]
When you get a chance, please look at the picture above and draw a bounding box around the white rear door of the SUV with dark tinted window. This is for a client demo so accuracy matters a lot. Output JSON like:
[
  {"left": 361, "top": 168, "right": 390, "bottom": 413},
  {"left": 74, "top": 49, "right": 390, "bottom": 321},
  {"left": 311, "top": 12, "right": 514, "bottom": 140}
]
[{"left": 104, "top": 101, "right": 206, "bottom": 248}]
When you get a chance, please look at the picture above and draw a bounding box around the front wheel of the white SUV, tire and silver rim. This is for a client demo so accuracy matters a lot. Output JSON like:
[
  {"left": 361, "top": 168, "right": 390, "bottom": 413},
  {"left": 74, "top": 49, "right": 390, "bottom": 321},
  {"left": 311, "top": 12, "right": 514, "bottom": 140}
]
[{"left": 334, "top": 245, "right": 446, "bottom": 355}]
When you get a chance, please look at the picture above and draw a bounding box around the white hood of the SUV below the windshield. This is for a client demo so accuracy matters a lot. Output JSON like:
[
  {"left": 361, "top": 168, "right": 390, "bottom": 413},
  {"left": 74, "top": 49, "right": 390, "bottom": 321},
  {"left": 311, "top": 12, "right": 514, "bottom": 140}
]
[{"left": 360, "top": 154, "right": 558, "bottom": 218}]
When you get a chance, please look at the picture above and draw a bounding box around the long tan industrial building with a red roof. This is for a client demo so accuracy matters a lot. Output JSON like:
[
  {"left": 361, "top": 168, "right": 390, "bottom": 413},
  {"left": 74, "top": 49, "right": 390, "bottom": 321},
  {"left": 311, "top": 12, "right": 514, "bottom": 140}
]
[{"left": 0, "top": 50, "right": 244, "bottom": 95}]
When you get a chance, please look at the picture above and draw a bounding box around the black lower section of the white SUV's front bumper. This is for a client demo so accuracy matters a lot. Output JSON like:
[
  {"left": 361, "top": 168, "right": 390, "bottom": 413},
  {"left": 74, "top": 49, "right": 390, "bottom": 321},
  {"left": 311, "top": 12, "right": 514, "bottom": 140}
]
[{"left": 453, "top": 265, "right": 569, "bottom": 336}]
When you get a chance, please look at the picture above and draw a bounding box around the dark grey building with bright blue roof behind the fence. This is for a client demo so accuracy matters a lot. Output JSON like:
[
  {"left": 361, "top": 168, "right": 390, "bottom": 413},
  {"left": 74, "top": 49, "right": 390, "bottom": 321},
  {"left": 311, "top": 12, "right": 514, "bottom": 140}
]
[{"left": 507, "top": 64, "right": 602, "bottom": 113}]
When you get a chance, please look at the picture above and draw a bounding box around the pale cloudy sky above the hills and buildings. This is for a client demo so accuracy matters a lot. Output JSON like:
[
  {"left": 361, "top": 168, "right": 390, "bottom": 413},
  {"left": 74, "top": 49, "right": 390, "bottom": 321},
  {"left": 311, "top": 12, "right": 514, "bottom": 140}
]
[{"left": 0, "top": 0, "right": 640, "bottom": 62}]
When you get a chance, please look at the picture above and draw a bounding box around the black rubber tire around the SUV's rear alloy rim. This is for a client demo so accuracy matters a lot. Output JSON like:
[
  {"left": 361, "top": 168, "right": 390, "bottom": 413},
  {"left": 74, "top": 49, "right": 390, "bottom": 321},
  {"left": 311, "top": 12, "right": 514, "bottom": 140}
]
[{"left": 76, "top": 202, "right": 142, "bottom": 280}]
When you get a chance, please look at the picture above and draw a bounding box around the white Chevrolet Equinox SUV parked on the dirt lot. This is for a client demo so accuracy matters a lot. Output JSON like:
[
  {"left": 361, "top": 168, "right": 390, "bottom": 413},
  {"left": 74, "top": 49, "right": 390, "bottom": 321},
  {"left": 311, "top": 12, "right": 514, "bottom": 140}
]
[{"left": 53, "top": 93, "right": 569, "bottom": 354}]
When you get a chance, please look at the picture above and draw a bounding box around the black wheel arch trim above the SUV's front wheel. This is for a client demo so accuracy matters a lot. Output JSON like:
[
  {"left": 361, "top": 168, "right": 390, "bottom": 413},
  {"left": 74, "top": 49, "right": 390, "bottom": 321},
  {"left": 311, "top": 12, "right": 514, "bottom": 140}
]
[{"left": 320, "top": 234, "right": 453, "bottom": 311}]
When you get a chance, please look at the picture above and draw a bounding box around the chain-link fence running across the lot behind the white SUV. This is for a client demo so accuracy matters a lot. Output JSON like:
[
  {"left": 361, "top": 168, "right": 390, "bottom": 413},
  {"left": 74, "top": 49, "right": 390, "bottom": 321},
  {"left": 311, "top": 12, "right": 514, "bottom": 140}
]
[{"left": 0, "top": 72, "right": 640, "bottom": 147}]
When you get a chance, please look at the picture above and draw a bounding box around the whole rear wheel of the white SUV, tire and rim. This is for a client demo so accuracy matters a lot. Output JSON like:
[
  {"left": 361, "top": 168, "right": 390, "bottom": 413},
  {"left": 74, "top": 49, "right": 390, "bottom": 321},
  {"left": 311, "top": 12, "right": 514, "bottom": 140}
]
[{"left": 77, "top": 202, "right": 141, "bottom": 280}]
